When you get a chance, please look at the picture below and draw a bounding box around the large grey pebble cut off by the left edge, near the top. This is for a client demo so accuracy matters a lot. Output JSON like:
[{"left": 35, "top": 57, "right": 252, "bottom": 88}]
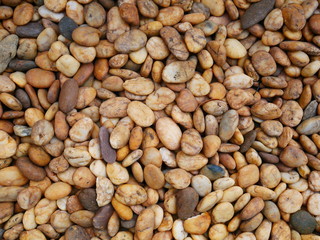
[{"left": 0, "top": 34, "right": 19, "bottom": 73}]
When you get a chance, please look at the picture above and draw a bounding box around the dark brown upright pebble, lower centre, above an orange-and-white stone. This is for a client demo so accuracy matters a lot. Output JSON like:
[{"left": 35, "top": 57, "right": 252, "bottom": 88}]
[{"left": 176, "top": 187, "right": 199, "bottom": 220}]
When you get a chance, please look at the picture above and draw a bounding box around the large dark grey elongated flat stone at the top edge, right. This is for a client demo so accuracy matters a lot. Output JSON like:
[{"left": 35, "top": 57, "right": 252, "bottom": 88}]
[{"left": 240, "top": 0, "right": 275, "bottom": 29}]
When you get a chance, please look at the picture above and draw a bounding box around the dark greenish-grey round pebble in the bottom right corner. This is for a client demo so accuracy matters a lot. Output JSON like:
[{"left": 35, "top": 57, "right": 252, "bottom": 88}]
[{"left": 290, "top": 210, "right": 317, "bottom": 234}]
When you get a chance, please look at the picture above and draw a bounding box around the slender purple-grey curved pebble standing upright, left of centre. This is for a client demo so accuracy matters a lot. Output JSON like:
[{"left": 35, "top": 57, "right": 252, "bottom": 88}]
[{"left": 99, "top": 126, "right": 117, "bottom": 163}]
